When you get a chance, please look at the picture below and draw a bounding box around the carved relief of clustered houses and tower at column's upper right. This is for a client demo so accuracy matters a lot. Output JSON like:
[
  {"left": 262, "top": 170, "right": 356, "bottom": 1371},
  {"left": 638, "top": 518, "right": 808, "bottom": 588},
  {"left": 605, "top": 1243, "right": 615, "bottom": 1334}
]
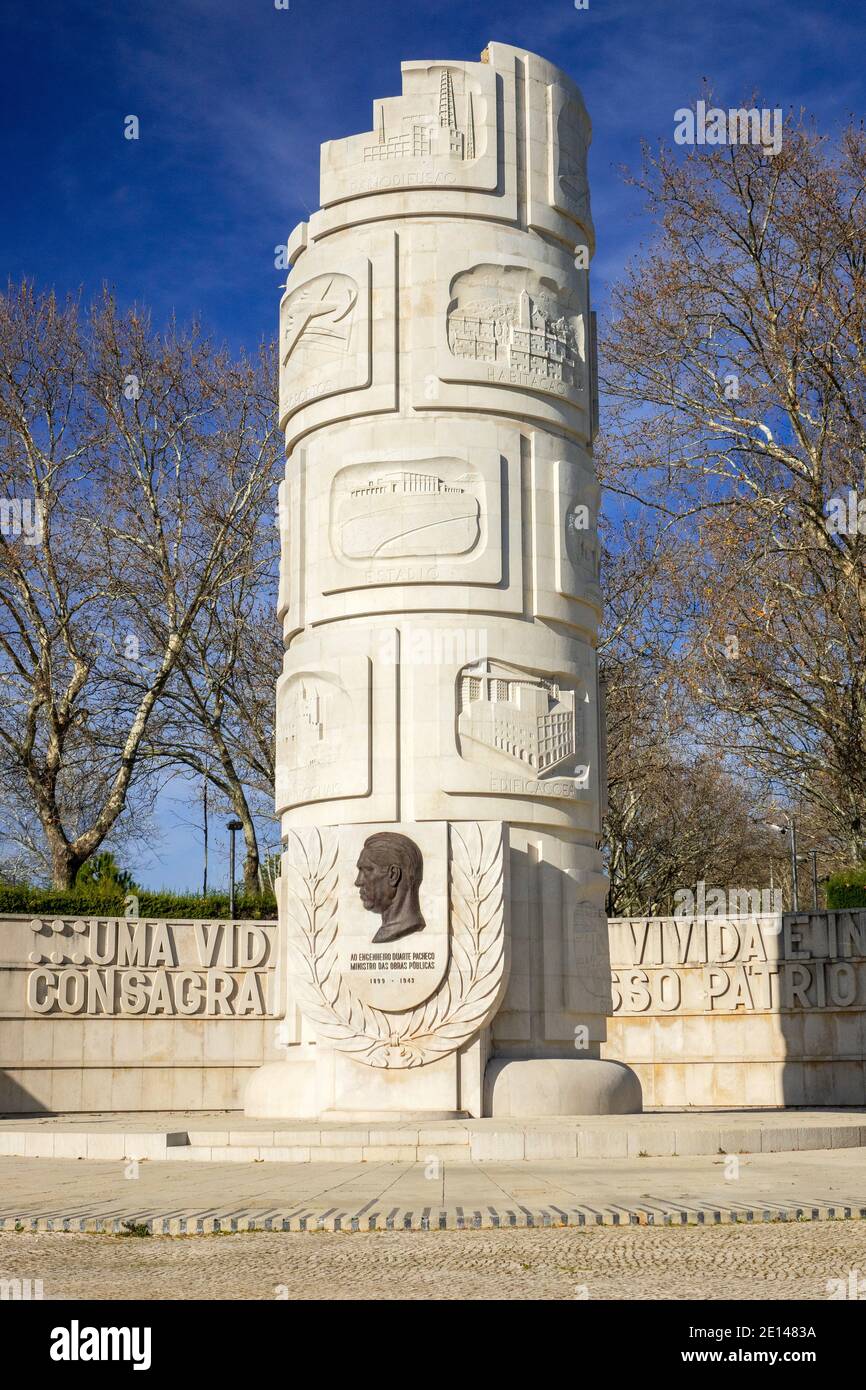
[{"left": 448, "top": 265, "right": 587, "bottom": 388}]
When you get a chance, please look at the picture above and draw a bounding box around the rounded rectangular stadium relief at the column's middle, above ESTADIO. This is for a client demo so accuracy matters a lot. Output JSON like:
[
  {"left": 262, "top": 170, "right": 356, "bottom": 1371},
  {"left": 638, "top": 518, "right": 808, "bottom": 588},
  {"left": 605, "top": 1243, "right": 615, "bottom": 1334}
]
[{"left": 331, "top": 459, "right": 481, "bottom": 560}]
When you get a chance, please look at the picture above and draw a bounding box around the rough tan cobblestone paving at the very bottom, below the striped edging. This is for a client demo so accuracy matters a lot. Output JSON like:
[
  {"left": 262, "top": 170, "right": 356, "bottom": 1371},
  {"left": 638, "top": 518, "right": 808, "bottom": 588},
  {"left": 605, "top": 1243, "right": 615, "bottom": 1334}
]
[{"left": 0, "top": 1220, "right": 866, "bottom": 1301}]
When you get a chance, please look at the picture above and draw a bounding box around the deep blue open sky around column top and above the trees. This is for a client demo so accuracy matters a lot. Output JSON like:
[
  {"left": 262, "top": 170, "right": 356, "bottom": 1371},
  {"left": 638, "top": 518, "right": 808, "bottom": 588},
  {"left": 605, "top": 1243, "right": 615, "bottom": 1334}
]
[{"left": 0, "top": 0, "right": 866, "bottom": 887}]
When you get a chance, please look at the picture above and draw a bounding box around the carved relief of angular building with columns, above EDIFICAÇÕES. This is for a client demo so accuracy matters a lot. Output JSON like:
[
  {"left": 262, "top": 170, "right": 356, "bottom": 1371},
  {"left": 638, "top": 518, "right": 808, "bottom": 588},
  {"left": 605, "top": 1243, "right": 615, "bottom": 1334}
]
[{"left": 457, "top": 657, "right": 577, "bottom": 774}]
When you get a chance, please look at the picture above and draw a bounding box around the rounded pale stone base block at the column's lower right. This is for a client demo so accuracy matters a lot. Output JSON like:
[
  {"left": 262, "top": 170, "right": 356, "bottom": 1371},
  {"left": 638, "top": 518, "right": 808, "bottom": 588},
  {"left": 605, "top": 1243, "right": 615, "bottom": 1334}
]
[{"left": 484, "top": 1056, "right": 644, "bottom": 1119}]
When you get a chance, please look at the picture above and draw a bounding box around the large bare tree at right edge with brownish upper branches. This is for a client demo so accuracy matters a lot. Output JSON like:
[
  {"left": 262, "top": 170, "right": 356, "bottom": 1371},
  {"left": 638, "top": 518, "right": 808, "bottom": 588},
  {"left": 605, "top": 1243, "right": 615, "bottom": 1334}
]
[{"left": 602, "top": 118, "right": 866, "bottom": 858}]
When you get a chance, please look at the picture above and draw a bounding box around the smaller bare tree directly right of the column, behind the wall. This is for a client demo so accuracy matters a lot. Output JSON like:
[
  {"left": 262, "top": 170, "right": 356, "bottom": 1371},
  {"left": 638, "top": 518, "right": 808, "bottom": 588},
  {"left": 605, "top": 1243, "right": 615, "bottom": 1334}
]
[{"left": 601, "top": 514, "right": 767, "bottom": 916}]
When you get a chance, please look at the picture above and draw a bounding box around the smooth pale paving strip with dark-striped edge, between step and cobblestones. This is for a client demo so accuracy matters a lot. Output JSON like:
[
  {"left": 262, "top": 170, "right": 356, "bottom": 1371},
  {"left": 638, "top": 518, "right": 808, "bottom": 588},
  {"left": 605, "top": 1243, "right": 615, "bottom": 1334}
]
[{"left": 0, "top": 1150, "right": 866, "bottom": 1241}]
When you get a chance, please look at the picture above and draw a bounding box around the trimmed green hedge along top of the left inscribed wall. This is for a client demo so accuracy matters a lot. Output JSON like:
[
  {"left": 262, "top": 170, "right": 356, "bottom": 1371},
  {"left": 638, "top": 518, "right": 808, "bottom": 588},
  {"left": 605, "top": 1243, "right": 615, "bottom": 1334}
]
[{"left": 0, "top": 885, "right": 277, "bottom": 922}]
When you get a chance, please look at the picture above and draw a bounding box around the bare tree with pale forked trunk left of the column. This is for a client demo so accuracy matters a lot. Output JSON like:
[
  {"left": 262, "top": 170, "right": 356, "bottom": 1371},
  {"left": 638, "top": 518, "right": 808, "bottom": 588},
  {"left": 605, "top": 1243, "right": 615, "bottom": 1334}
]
[{"left": 0, "top": 285, "right": 277, "bottom": 887}]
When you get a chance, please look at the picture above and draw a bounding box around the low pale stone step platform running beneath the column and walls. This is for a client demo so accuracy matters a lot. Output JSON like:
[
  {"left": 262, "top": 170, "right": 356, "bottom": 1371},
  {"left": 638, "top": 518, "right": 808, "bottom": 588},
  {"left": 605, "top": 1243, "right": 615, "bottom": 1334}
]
[{"left": 0, "top": 1111, "right": 866, "bottom": 1165}]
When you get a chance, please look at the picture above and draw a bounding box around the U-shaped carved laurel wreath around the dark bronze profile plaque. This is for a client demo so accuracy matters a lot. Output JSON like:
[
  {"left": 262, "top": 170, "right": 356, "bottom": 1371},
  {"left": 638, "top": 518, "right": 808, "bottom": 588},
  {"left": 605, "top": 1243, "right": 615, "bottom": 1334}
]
[{"left": 282, "top": 821, "right": 506, "bottom": 1068}]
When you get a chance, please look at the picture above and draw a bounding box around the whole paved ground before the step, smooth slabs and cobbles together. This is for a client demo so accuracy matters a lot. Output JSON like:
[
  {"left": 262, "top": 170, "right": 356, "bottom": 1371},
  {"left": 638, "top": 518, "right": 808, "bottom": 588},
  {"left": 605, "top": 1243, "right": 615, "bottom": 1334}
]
[{"left": 0, "top": 1116, "right": 866, "bottom": 1302}]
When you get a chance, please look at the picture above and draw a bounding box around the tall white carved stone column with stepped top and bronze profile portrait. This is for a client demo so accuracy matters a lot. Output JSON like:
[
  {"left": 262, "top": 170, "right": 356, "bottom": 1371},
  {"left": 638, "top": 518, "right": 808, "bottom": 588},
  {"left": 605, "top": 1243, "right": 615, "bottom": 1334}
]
[{"left": 247, "top": 43, "right": 639, "bottom": 1115}]
